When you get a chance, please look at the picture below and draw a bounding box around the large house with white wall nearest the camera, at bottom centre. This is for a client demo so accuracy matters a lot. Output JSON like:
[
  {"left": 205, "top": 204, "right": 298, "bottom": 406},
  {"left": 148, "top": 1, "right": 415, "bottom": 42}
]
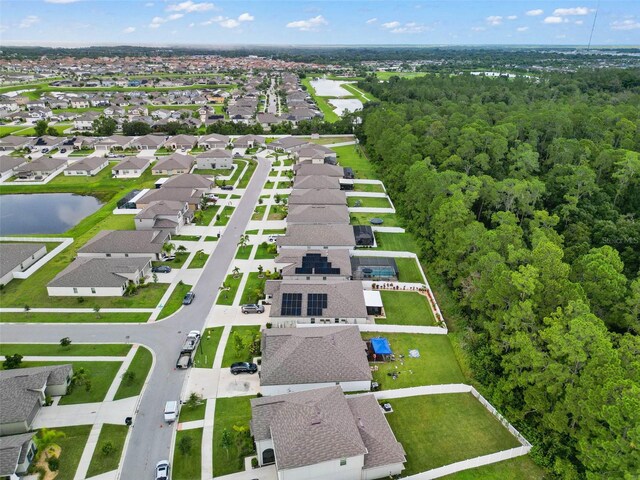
[{"left": 251, "top": 386, "right": 406, "bottom": 480}]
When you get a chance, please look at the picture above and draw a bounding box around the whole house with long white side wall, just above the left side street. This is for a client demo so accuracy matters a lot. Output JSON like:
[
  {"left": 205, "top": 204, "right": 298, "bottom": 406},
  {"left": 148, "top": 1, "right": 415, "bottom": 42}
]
[{"left": 47, "top": 256, "right": 151, "bottom": 297}]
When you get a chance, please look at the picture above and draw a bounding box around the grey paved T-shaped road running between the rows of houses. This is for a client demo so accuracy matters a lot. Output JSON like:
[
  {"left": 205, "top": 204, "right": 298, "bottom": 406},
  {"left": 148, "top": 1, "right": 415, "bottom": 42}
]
[{"left": 0, "top": 158, "right": 271, "bottom": 479}]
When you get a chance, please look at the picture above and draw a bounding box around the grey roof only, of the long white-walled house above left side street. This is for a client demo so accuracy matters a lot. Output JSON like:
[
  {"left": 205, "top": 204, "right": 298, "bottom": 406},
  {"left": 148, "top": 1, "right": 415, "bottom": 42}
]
[{"left": 47, "top": 256, "right": 151, "bottom": 287}]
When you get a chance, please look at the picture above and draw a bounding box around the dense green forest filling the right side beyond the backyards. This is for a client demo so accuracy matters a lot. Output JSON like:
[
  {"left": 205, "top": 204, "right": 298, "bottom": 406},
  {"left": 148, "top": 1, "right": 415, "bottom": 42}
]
[{"left": 358, "top": 71, "right": 640, "bottom": 480}]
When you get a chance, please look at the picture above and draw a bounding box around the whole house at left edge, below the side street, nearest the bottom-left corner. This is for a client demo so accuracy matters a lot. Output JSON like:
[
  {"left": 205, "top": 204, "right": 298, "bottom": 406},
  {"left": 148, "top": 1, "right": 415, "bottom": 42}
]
[{"left": 0, "top": 364, "right": 73, "bottom": 436}]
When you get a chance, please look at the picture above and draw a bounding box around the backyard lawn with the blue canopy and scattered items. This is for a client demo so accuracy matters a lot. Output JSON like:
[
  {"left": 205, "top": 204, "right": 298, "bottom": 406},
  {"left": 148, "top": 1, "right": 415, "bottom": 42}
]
[{"left": 362, "top": 332, "right": 466, "bottom": 390}]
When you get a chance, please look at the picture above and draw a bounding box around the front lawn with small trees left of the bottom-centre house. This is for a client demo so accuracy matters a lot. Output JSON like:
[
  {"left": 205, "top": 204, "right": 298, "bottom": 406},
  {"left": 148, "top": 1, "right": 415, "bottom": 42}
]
[{"left": 214, "top": 396, "right": 255, "bottom": 478}]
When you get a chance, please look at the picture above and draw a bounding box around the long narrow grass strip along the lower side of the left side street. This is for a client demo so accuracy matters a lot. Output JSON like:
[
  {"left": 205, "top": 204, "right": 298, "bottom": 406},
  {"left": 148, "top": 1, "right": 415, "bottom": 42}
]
[{"left": 0, "top": 344, "right": 131, "bottom": 357}]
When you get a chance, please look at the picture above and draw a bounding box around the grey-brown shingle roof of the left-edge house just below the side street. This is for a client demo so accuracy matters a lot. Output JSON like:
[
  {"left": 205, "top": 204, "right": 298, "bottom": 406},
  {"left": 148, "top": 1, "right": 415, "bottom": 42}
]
[{"left": 0, "top": 364, "right": 72, "bottom": 423}]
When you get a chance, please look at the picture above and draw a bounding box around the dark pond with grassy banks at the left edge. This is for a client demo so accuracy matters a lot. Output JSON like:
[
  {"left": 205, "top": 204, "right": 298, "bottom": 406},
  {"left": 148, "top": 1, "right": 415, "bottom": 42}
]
[{"left": 0, "top": 193, "right": 102, "bottom": 235}]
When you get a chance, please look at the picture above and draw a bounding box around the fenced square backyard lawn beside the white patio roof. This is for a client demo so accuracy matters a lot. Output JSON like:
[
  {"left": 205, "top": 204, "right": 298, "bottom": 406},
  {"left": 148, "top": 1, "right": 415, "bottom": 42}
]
[{"left": 376, "top": 291, "right": 437, "bottom": 326}]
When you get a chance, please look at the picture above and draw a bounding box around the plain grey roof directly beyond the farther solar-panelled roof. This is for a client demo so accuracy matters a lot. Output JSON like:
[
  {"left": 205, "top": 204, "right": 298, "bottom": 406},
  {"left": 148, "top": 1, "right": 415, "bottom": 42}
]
[{"left": 276, "top": 224, "right": 356, "bottom": 248}]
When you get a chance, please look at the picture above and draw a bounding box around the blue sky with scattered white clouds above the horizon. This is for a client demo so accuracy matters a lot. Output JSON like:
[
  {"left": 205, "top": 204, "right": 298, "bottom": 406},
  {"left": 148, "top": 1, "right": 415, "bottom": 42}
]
[{"left": 0, "top": 0, "right": 640, "bottom": 46}]
